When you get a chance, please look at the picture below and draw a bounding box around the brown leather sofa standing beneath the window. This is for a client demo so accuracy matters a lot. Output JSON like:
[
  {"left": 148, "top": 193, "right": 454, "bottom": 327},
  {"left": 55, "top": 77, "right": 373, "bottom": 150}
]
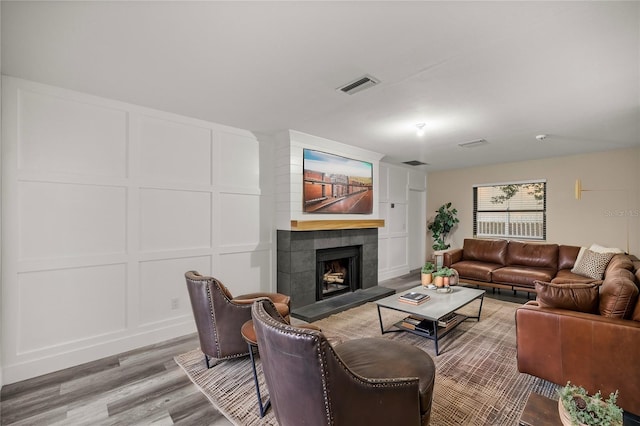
[{"left": 444, "top": 238, "right": 593, "bottom": 293}]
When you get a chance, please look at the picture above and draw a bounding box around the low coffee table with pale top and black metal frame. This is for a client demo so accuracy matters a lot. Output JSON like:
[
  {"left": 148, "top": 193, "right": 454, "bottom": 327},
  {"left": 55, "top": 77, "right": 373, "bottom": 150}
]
[{"left": 375, "top": 286, "right": 484, "bottom": 356}]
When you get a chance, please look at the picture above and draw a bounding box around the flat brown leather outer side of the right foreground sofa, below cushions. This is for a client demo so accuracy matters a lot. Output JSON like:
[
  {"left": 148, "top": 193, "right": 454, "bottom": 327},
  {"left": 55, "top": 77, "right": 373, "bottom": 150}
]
[{"left": 516, "top": 302, "right": 640, "bottom": 414}]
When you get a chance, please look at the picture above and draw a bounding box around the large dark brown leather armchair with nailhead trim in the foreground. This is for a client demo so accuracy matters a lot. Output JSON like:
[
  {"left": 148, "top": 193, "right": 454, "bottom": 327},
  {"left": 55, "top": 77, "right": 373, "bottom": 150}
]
[{"left": 252, "top": 299, "right": 435, "bottom": 426}]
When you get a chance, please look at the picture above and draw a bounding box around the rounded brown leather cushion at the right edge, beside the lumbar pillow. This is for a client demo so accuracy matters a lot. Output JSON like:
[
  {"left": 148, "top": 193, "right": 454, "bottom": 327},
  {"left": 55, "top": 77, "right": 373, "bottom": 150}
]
[{"left": 599, "top": 269, "right": 639, "bottom": 319}]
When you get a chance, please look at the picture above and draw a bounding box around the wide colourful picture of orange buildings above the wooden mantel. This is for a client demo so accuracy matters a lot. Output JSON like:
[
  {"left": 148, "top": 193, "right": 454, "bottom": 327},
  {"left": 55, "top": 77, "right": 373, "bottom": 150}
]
[{"left": 302, "top": 149, "right": 373, "bottom": 214}]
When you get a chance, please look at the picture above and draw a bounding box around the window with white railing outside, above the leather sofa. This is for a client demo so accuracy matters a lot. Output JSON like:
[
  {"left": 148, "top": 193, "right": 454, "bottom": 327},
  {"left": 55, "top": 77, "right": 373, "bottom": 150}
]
[{"left": 473, "top": 180, "right": 547, "bottom": 240}]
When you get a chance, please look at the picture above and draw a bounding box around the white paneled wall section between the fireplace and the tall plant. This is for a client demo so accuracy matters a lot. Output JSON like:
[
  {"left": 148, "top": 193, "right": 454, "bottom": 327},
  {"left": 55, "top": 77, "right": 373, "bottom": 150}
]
[{"left": 378, "top": 163, "right": 426, "bottom": 280}]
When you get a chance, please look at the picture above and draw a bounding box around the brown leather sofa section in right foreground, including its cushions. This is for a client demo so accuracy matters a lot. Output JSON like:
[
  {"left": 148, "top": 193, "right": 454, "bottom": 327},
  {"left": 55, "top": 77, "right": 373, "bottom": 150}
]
[{"left": 516, "top": 254, "right": 640, "bottom": 415}]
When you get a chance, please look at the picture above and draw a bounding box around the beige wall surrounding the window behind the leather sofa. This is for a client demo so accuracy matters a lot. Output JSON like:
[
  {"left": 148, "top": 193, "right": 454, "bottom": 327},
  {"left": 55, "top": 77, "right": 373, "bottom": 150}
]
[{"left": 427, "top": 147, "right": 640, "bottom": 255}]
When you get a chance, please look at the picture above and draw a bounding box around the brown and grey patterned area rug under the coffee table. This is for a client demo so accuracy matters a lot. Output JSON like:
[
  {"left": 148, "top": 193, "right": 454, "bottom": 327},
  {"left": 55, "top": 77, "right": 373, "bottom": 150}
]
[{"left": 175, "top": 298, "right": 558, "bottom": 426}]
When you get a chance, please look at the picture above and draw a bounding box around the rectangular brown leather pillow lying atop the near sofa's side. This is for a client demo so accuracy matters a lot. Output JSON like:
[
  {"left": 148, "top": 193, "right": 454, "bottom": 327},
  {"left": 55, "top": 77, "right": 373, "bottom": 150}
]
[{"left": 535, "top": 281, "right": 599, "bottom": 313}]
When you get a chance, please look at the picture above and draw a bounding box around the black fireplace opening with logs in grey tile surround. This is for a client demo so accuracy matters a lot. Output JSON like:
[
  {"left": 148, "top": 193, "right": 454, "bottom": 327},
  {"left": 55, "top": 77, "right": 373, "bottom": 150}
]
[{"left": 316, "top": 246, "right": 362, "bottom": 300}]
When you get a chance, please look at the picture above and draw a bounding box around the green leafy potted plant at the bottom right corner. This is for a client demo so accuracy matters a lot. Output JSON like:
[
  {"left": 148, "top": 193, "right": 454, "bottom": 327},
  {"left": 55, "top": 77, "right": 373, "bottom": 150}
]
[{"left": 558, "top": 382, "right": 622, "bottom": 426}]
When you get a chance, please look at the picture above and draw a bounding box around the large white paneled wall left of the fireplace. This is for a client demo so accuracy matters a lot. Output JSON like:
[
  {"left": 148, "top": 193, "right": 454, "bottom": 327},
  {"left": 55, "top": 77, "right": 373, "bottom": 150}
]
[{"left": 0, "top": 77, "right": 275, "bottom": 383}]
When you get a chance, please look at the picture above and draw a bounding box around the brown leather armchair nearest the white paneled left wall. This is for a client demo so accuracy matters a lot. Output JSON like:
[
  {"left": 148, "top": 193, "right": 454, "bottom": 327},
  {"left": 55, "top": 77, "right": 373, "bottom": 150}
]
[{"left": 185, "top": 271, "right": 290, "bottom": 368}]
